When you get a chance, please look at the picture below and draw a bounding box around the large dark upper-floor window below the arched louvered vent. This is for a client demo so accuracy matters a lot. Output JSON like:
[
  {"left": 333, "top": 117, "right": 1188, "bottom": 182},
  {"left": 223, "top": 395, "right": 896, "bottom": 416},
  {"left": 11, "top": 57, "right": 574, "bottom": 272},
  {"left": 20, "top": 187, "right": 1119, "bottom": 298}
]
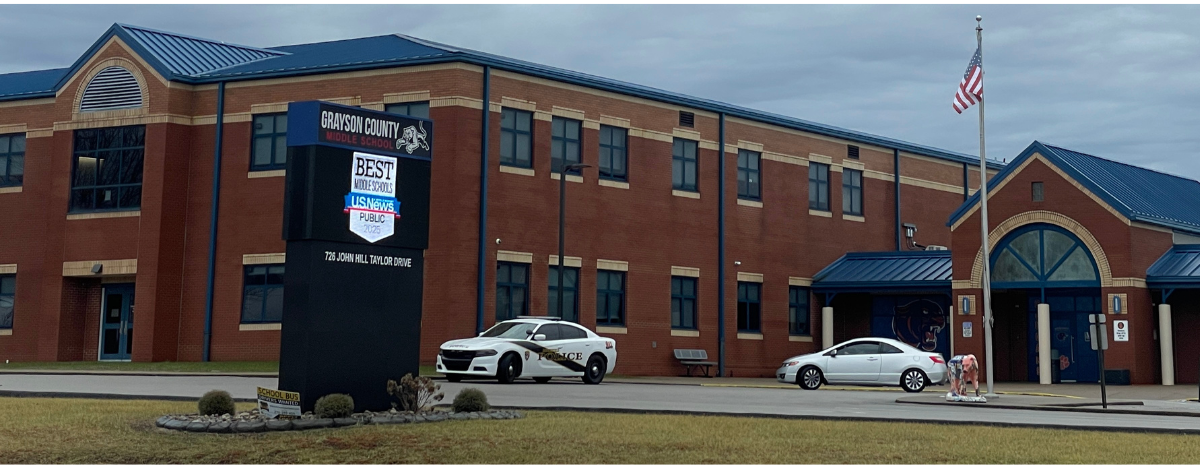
[{"left": 71, "top": 126, "right": 146, "bottom": 212}]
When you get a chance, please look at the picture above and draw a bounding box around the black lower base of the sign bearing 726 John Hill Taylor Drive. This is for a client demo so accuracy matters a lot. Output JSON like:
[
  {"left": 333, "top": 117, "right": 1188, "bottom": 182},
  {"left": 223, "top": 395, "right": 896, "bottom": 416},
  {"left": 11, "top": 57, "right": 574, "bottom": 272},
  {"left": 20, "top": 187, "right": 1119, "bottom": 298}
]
[{"left": 280, "top": 241, "right": 424, "bottom": 412}]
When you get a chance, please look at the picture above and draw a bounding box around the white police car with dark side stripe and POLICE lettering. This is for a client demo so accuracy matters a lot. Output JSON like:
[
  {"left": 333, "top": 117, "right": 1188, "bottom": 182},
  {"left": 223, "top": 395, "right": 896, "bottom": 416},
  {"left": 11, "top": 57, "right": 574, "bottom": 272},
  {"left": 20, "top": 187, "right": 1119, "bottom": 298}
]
[{"left": 437, "top": 316, "right": 617, "bottom": 385}]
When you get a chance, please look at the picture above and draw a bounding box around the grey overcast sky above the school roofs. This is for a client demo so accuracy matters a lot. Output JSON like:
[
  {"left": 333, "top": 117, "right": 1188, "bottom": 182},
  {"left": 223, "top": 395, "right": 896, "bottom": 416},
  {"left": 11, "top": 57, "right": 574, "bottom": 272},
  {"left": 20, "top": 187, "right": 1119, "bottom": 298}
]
[{"left": 0, "top": 5, "right": 1200, "bottom": 179}]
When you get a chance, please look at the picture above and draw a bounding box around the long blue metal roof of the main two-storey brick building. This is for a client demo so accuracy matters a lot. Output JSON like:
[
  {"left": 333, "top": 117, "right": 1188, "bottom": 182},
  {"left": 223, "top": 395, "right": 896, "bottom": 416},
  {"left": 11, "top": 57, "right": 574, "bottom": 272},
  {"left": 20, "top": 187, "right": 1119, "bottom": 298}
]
[{"left": 0, "top": 24, "right": 1003, "bottom": 169}]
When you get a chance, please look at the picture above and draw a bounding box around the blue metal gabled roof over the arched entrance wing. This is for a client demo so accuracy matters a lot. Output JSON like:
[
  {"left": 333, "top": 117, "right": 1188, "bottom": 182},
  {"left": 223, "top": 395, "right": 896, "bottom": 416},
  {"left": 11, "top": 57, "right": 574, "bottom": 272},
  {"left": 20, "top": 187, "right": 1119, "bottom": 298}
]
[{"left": 947, "top": 140, "right": 1200, "bottom": 234}]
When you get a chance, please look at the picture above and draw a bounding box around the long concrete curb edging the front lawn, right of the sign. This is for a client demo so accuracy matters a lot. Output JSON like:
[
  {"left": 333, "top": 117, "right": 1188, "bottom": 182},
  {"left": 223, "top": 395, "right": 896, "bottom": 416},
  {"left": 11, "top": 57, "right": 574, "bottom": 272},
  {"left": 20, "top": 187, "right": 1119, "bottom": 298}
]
[{"left": 492, "top": 404, "right": 1200, "bottom": 435}]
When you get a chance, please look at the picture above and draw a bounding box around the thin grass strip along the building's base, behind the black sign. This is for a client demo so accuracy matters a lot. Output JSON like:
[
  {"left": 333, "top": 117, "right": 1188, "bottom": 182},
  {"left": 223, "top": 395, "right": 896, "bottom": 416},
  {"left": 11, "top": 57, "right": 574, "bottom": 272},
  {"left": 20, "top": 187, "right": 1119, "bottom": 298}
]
[{"left": 0, "top": 362, "right": 437, "bottom": 376}]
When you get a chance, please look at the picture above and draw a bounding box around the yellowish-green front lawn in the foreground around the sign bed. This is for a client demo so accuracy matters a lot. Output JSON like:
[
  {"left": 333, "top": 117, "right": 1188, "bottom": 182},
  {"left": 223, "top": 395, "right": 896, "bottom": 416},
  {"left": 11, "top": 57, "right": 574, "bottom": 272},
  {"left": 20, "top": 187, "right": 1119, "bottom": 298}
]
[{"left": 0, "top": 398, "right": 1200, "bottom": 464}]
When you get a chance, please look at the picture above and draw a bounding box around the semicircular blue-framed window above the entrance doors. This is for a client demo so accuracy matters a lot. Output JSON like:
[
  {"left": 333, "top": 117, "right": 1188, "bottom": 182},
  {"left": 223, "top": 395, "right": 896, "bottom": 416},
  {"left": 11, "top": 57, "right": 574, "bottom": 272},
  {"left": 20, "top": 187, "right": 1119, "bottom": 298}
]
[{"left": 991, "top": 224, "right": 1099, "bottom": 288}]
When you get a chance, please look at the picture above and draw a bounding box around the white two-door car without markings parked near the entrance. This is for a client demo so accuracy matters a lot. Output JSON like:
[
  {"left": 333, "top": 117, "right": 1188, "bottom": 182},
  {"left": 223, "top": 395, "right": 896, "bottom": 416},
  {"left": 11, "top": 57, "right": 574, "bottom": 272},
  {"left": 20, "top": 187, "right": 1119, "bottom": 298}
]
[{"left": 775, "top": 338, "right": 947, "bottom": 392}]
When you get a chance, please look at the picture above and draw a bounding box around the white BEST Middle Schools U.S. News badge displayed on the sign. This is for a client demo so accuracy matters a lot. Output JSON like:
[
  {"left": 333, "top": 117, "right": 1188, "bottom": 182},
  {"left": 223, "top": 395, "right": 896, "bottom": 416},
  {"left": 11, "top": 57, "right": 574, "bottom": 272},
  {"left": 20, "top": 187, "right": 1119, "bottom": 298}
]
[{"left": 343, "top": 152, "right": 400, "bottom": 243}]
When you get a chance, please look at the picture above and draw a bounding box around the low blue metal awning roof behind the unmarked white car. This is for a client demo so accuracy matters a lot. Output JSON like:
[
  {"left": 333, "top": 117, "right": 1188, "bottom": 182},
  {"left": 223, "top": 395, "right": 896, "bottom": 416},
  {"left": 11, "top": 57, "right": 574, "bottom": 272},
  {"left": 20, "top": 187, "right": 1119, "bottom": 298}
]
[{"left": 812, "top": 250, "right": 950, "bottom": 290}]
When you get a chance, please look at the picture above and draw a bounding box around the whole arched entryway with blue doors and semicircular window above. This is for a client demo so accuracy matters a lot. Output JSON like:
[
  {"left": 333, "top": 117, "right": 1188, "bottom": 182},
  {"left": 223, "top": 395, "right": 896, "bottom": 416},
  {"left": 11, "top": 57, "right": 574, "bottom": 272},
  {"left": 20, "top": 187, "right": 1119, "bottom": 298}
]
[{"left": 991, "top": 223, "right": 1100, "bottom": 382}]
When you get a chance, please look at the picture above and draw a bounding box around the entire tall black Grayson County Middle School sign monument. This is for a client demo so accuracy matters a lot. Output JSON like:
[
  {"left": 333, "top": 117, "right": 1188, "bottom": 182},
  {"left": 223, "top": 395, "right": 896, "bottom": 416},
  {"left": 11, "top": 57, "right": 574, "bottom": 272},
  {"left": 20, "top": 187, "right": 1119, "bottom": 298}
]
[{"left": 280, "top": 102, "right": 433, "bottom": 411}]
